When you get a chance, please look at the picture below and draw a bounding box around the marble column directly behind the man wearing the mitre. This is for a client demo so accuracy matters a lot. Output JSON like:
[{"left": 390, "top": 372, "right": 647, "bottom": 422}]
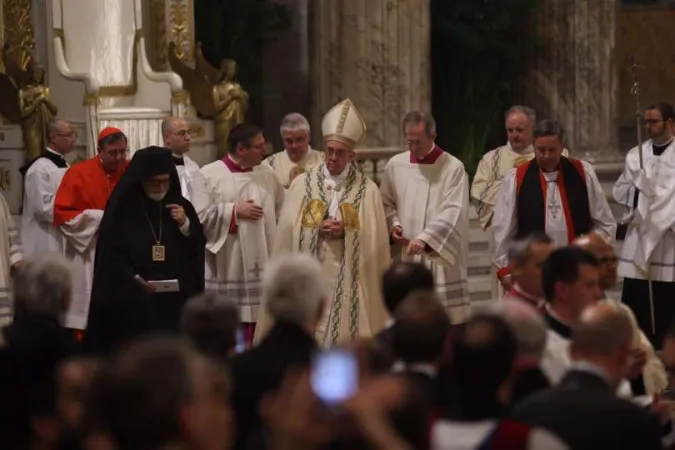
[{"left": 310, "top": 0, "right": 431, "bottom": 148}]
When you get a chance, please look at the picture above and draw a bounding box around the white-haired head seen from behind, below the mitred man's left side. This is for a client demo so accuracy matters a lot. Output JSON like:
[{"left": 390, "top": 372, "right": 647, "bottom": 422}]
[{"left": 262, "top": 253, "right": 327, "bottom": 325}]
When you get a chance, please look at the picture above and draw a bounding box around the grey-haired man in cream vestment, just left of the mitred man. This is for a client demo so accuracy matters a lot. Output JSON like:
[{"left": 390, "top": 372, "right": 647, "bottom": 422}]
[{"left": 263, "top": 113, "right": 323, "bottom": 189}]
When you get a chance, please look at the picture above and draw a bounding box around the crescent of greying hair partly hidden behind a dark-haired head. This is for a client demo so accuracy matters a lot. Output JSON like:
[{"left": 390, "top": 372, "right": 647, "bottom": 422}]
[{"left": 476, "top": 298, "right": 546, "bottom": 358}]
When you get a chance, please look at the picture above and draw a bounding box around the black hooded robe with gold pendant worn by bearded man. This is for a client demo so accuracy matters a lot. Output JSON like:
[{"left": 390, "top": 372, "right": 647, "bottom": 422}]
[{"left": 84, "top": 147, "right": 206, "bottom": 354}]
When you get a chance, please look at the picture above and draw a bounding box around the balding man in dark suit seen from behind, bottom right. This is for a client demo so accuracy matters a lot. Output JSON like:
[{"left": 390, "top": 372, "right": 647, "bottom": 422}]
[{"left": 514, "top": 304, "right": 662, "bottom": 450}]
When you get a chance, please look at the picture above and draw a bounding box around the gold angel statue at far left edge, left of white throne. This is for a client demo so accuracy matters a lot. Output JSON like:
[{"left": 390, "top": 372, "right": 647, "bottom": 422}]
[{"left": 0, "top": 46, "right": 57, "bottom": 161}]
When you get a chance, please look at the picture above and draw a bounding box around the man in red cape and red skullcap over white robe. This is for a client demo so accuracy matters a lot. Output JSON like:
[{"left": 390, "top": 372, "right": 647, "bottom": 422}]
[{"left": 54, "top": 127, "right": 128, "bottom": 337}]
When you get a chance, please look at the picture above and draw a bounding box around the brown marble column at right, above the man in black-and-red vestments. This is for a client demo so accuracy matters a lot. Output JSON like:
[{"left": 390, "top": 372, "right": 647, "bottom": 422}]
[{"left": 526, "top": 0, "right": 619, "bottom": 162}]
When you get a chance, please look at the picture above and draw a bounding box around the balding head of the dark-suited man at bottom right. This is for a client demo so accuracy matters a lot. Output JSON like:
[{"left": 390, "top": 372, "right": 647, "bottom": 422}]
[{"left": 571, "top": 303, "right": 633, "bottom": 385}]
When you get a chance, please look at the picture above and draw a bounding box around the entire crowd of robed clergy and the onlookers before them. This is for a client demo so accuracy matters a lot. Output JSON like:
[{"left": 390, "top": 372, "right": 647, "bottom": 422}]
[{"left": 0, "top": 96, "right": 675, "bottom": 450}]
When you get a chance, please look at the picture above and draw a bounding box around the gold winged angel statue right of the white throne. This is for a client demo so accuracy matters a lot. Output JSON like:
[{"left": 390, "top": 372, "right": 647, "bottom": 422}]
[{"left": 169, "top": 42, "right": 248, "bottom": 157}]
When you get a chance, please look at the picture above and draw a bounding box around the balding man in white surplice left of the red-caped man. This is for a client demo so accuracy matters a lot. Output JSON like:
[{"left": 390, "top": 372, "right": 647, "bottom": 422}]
[{"left": 20, "top": 120, "right": 76, "bottom": 256}]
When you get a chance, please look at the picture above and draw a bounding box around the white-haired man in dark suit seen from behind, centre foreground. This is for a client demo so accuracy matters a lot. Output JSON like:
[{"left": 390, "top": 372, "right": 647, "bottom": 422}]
[{"left": 230, "top": 254, "right": 328, "bottom": 449}]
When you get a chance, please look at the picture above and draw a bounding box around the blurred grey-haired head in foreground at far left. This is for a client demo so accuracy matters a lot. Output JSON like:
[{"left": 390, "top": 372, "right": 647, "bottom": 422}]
[{"left": 13, "top": 253, "right": 73, "bottom": 318}]
